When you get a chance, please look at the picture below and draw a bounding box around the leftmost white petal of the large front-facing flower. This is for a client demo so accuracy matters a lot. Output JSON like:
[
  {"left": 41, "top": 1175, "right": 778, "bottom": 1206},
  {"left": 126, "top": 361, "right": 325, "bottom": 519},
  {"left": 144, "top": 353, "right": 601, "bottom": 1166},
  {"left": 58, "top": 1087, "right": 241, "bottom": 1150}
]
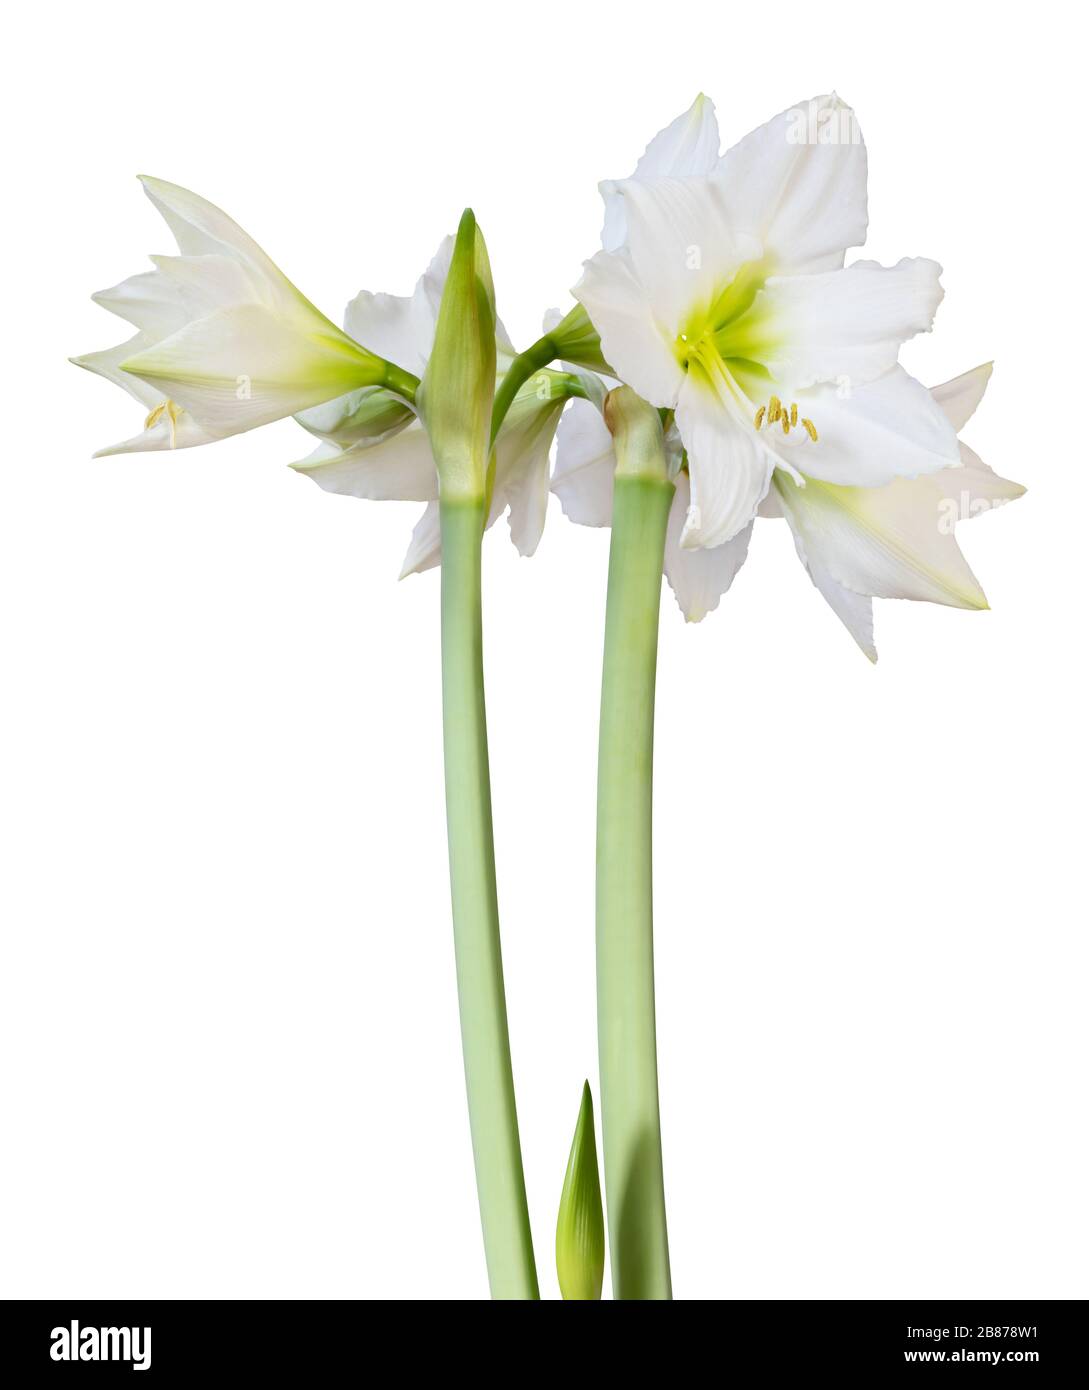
[{"left": 572, "top": 252, "right": 684, "bottom": 407}]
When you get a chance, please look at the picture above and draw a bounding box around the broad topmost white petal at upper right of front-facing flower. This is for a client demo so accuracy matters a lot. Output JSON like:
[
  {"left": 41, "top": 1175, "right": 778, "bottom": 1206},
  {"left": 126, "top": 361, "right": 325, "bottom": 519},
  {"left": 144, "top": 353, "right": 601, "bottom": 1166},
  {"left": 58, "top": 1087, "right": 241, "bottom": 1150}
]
[{"left": 719, "top": 93, "right": 866, "bottom": 270}]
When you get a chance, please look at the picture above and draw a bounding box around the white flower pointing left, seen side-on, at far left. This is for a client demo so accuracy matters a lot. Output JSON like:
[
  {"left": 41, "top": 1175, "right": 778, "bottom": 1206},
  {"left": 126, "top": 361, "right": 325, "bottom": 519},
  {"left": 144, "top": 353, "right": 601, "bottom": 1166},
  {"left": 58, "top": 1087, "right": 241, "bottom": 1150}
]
[{"left": 72, "top": 178, "right": 403, "bottom": 455}]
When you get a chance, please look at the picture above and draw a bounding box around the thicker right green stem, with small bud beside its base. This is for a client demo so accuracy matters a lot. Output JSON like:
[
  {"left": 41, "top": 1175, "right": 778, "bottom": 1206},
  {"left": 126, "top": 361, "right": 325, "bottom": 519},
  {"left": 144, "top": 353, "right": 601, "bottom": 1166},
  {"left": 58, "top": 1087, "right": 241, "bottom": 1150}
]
[{"left": 597, "top": 475, "right": 673, "bottom": 1298}]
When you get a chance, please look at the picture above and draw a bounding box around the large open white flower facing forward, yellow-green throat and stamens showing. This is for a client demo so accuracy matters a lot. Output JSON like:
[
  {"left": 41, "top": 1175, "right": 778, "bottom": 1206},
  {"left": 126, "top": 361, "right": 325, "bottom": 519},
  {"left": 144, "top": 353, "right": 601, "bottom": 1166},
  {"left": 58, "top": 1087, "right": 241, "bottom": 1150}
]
[{"left": 574, "top": 88, "right": 957, "bottom": 548}]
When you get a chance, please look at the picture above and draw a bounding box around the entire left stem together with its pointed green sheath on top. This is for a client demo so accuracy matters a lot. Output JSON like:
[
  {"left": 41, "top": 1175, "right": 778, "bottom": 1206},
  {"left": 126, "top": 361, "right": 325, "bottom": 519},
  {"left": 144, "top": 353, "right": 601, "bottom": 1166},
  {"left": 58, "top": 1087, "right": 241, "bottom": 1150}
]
[{"left": 416, "top": 211, "right": 540, "bottom": 1298}]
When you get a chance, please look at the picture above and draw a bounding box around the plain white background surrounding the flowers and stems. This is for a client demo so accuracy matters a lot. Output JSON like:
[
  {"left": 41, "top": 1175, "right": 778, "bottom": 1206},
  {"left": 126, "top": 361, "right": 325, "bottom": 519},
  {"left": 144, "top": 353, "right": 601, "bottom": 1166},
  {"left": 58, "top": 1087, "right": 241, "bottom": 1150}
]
[{"left": 0, "top": 0, "right": 1089, "bottom": 1298}]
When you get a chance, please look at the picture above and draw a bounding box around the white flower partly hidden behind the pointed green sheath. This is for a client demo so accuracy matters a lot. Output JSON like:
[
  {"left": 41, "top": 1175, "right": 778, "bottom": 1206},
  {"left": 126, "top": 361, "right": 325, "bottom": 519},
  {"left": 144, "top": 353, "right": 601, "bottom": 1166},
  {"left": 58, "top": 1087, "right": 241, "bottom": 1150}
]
[{"left": 292, "top": 244, "right": 570, "bottom": 578}]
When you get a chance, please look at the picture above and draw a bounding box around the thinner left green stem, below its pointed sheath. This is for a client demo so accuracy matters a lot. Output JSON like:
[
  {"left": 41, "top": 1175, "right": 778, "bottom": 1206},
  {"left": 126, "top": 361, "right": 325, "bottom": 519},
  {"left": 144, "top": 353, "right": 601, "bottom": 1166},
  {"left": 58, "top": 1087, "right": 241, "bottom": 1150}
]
[{"left": 439, "top": 502, "right": 540, "bottom": 1298}]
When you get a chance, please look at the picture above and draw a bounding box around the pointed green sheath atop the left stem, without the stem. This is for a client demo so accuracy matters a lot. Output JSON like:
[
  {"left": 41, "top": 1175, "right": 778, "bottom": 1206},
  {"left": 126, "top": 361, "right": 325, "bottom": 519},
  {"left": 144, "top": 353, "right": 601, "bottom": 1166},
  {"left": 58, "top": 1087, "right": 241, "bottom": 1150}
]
[{"left": 416, "top": 209, "right": 495, "bottom": 502}]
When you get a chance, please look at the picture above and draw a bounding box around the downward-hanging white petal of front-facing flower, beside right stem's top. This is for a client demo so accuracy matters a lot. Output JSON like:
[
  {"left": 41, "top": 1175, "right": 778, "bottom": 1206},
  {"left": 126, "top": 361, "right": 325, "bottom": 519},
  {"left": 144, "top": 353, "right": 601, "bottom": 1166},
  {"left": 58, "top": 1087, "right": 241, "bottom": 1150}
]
[{"left": 676, "top": 363, "right": 773, "bottom": 546}]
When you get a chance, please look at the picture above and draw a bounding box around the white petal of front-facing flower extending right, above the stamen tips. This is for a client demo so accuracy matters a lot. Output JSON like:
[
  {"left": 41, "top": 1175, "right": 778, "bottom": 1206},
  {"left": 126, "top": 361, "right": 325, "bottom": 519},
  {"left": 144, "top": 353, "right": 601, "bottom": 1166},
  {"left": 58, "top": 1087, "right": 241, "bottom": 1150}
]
[{"left": 751, "top": 257, "right": 943, "bottom": 391}]
